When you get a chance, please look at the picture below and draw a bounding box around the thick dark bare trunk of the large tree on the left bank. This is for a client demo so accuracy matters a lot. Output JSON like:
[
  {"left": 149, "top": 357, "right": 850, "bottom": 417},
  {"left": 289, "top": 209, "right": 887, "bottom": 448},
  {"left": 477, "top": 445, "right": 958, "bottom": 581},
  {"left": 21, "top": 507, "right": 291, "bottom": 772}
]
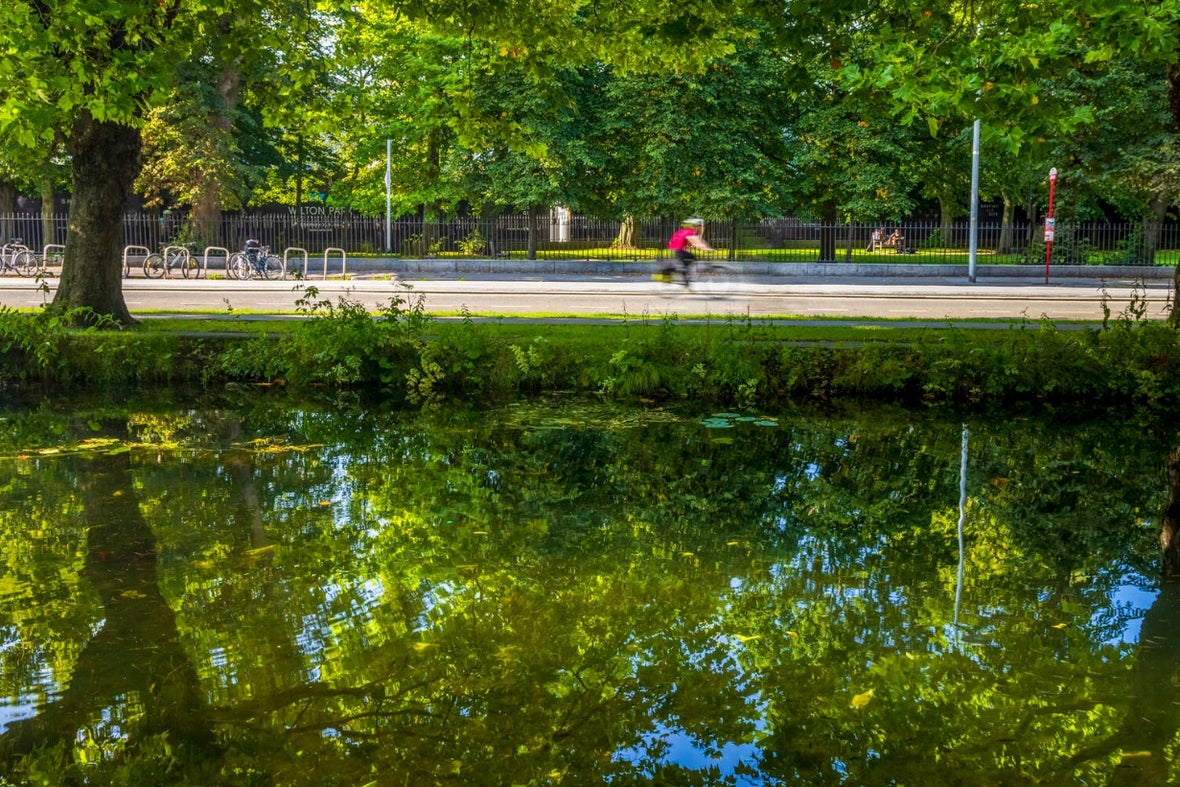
[{"left": 52, "top": 113, "right": 139, "bottom": 324}]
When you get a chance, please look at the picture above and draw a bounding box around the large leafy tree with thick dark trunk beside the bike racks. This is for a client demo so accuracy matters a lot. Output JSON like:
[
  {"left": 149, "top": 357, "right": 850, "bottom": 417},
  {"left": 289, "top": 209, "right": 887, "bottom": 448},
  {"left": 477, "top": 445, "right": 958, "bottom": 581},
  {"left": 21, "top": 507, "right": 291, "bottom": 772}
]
[{"left": 0, "top": 0, "right": 207, "bottom": 322}]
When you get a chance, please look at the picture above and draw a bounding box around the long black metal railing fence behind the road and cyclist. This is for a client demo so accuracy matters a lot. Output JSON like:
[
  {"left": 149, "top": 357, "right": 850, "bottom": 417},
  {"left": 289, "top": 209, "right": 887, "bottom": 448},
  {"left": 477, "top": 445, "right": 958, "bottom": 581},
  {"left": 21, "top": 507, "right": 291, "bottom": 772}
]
[{"left": 0, "top": 209, "right": 1180, "bottom": 267}]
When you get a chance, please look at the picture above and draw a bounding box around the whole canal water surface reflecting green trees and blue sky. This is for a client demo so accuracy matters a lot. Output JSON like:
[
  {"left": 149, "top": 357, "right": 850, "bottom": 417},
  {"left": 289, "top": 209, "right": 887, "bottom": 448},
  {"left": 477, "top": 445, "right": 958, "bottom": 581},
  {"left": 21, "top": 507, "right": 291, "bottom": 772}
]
[{"left": 0, "top": 400, "right": 1180, "bottom": 785}]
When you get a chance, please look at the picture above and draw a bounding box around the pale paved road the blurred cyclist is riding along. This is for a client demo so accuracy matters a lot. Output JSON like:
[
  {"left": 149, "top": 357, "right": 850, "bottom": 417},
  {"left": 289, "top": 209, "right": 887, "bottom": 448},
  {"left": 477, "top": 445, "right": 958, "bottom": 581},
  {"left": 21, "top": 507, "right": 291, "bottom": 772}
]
[{"left": 0, "top": 274, "right": 1171, "bottom": 321}]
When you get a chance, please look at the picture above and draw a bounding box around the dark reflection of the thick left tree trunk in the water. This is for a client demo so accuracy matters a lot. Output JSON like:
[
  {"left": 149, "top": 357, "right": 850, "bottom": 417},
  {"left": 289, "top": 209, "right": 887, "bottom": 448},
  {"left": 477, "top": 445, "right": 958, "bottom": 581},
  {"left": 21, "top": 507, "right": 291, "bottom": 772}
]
[{"left": 0, "top": 452, "right": 214, "bottom": 762}]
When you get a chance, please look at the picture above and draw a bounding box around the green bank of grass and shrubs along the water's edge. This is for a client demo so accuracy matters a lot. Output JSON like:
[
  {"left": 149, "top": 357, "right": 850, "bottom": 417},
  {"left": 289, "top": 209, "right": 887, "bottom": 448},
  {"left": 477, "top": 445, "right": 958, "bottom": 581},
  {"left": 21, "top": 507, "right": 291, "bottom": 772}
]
[{"left": 0, "top": 289, "right": 1180, "bottom": 408}]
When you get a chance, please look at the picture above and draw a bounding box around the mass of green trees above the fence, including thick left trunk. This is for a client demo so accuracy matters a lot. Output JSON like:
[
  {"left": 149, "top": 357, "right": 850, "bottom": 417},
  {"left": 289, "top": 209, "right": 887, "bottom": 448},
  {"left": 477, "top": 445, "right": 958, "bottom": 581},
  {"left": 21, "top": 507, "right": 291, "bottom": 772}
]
[{"left": 0, "top": 0, "right": 1180, "bottom": 320}]
